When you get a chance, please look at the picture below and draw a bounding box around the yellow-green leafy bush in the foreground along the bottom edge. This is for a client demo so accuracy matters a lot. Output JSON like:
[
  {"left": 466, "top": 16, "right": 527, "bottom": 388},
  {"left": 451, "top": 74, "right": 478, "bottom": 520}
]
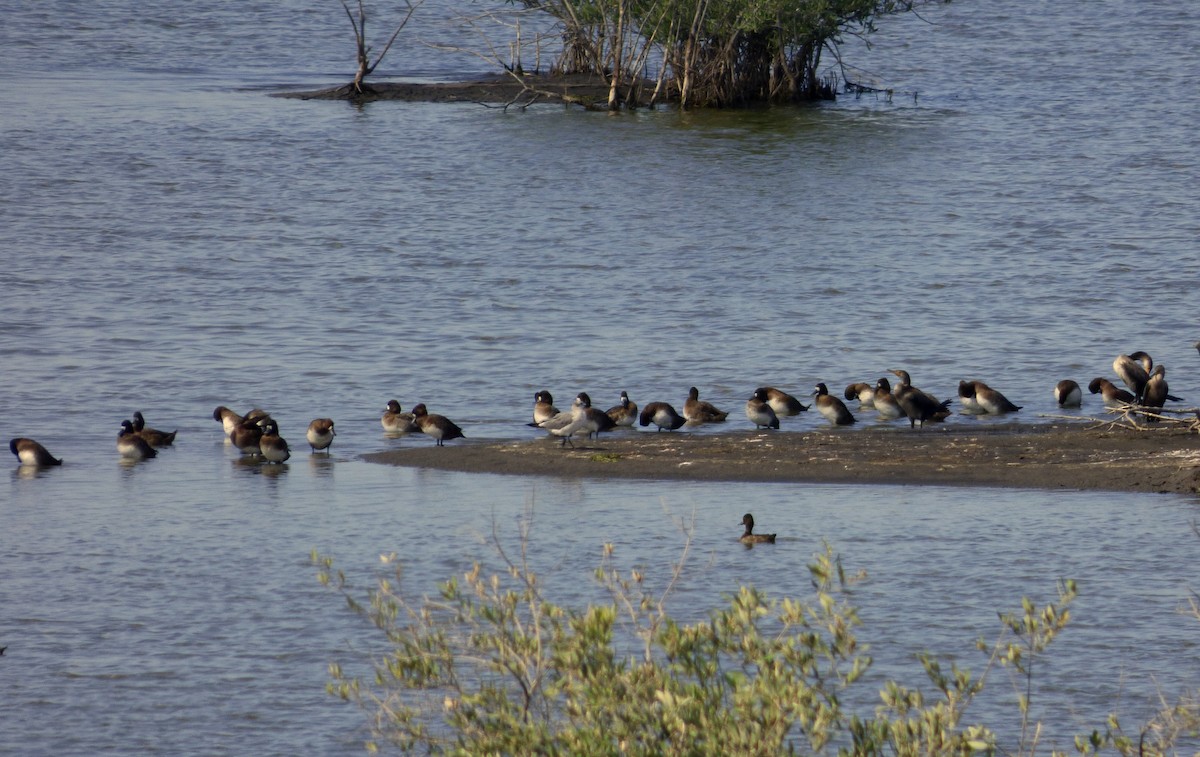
[{"left": 313, "top": 532, "right": 1200, "bottom": 756}]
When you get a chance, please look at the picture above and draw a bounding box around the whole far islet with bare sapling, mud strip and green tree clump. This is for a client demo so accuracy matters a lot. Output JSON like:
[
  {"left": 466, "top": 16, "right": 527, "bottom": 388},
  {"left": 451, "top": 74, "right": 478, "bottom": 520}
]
[{"left": 283, "top": 0, "right": 944, "bottom": 110}]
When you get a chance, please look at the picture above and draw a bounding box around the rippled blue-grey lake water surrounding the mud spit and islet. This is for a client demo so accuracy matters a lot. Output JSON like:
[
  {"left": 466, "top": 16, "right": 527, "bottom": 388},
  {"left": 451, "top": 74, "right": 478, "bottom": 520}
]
[{"left": 0, "top": 0, "right": 1200, "bottom": 755}]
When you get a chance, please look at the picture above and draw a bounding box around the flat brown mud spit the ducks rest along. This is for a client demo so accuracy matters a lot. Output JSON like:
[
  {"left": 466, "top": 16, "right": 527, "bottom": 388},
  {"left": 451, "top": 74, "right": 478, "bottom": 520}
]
[{"left": 364, "top": 422, "right": 1200, "bottom": 494}]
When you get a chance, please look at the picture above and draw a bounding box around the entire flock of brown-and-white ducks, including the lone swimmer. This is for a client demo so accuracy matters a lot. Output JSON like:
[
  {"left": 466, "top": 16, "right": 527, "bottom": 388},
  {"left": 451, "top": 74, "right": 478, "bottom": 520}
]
[{"left": 8, "top": 352, "right": 1200, "bottom": 470}]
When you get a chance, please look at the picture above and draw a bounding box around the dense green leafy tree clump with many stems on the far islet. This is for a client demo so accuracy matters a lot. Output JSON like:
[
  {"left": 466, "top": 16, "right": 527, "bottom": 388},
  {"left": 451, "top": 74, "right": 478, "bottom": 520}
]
[{"left": 510, "top": 0, "right": 942, "bottom": 108}]
